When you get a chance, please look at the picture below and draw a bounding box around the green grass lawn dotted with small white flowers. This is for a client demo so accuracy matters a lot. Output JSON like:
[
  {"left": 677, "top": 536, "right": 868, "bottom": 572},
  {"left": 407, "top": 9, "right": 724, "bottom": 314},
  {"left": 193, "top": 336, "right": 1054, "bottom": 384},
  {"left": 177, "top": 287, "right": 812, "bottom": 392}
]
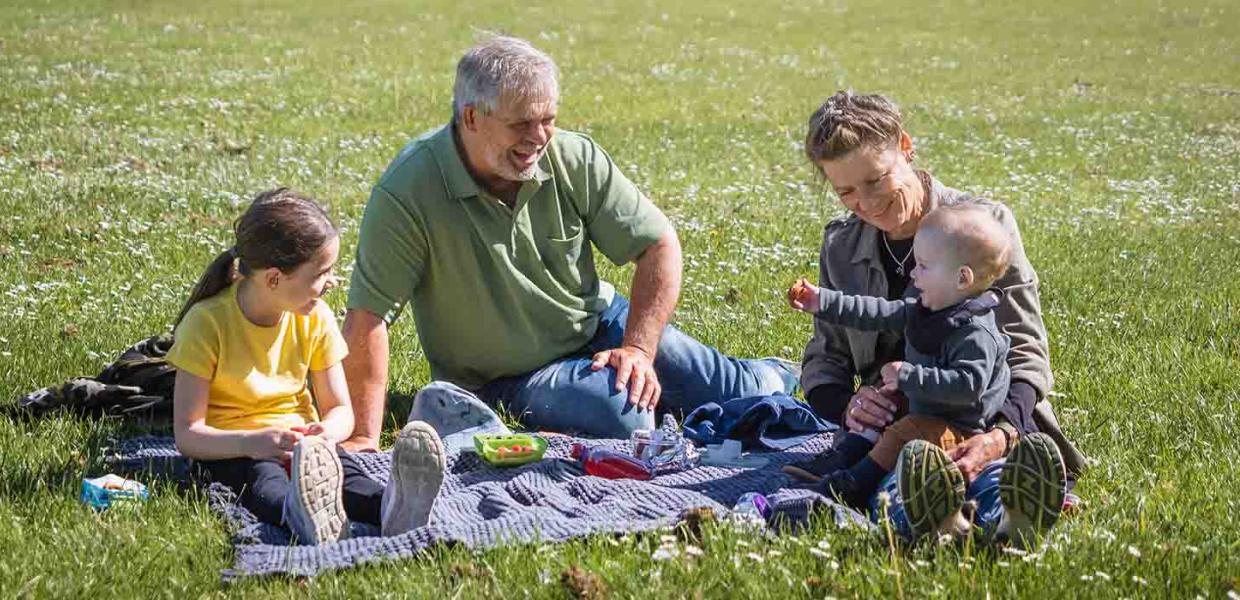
[{"left": 0, "top": 0, "right": 1240, "bottom": 598}]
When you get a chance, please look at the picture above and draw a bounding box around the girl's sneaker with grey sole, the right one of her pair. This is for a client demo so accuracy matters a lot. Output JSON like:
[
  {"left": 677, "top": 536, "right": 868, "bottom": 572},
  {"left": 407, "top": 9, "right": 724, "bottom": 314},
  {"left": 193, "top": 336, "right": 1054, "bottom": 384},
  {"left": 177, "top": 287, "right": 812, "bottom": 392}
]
[{"left": 382, "top": 420, "right": 444, "bottom": 536}]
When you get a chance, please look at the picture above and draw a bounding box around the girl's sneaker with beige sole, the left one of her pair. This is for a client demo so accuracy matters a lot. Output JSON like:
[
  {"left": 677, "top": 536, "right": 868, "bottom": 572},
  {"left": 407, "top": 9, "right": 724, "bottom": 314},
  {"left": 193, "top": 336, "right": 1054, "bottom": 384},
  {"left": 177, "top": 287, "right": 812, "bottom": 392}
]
[{"left": 284, "top": 435, "right": 348, "bottom": 545}]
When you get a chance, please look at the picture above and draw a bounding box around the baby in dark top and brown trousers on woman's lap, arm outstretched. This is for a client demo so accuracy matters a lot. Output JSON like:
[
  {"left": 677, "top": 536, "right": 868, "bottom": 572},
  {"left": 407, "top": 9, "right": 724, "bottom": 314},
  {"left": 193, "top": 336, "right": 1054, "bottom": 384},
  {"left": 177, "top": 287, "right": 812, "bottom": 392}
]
[{"left": 785, "top": 205, "right": 1011, "bottom": 507}]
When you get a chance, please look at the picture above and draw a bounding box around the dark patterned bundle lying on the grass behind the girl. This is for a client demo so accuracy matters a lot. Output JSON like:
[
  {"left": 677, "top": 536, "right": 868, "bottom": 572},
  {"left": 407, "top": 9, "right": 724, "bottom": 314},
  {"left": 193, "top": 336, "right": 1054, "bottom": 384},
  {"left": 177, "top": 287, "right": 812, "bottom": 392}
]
[{"left": 17, "top": 333, "right": 176, "bottom": 423}]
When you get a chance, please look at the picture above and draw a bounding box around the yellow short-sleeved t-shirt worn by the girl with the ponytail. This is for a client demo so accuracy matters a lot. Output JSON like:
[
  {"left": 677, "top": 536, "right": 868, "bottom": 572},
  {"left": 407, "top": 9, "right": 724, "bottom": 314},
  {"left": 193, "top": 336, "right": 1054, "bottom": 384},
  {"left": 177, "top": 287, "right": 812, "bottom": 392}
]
[{"left": 167, "top": 283, "right": 348, "bottom": 429}]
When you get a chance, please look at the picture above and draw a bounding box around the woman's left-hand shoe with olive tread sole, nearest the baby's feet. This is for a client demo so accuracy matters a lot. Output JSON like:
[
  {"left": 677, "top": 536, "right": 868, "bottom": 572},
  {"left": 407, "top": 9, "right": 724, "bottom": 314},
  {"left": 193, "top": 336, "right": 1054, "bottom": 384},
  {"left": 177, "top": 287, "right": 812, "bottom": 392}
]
[{"left": 895, "top": 440, "right": 970, "bottom": 539}]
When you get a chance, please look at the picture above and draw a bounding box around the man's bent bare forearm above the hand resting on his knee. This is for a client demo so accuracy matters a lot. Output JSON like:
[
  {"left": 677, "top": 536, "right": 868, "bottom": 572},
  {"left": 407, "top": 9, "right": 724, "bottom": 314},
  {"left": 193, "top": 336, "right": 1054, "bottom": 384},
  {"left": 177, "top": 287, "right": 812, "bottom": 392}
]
[{"left": 624, "top": 231, "right": 682, "bottom": 358}]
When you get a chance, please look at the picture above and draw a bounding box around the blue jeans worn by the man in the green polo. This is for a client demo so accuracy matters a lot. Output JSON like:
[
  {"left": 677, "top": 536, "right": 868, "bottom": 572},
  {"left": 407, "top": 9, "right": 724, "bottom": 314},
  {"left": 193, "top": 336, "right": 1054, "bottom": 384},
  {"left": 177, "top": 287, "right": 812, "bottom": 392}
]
[{"left": 468, "top": 294, "right": 796, "bottom": 438}]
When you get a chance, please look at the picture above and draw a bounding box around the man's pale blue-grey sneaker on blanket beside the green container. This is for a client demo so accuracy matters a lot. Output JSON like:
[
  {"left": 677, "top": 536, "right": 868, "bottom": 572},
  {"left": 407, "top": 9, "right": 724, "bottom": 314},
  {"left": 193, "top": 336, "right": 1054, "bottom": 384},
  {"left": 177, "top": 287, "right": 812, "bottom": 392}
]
[{"left": 407, "top": 382, "right": 512, "bottom": 452}]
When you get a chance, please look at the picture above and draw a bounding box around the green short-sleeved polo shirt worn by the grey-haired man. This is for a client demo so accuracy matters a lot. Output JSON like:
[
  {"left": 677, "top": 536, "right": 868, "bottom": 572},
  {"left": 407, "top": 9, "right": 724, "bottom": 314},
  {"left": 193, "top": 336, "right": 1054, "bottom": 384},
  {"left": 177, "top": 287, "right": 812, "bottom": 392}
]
[{"left": 348, "top": 125, "right": 671, "bottom": 389}]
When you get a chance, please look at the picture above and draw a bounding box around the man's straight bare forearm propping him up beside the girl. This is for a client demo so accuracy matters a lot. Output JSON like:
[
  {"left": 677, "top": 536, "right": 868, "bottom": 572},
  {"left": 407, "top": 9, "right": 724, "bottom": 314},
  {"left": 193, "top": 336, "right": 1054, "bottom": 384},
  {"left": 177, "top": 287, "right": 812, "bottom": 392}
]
[{"left": 341, "top": 310, "right": 388, "bottom": 444}]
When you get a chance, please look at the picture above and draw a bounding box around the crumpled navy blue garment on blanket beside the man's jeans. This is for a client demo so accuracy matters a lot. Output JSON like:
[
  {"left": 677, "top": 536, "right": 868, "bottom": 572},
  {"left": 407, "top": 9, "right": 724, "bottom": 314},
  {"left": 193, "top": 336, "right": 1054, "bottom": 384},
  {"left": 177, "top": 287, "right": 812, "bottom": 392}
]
[{"left": 683, "top": 393, "right": 837, "bottom": 450}]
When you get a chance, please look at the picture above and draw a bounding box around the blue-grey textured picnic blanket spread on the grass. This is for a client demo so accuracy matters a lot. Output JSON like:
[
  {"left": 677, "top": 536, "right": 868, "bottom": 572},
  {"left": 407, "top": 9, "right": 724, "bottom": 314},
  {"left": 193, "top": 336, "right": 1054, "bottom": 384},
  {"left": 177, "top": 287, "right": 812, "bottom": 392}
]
[{"left": 110, "top": 434, "right": 869, "bottom": 580}]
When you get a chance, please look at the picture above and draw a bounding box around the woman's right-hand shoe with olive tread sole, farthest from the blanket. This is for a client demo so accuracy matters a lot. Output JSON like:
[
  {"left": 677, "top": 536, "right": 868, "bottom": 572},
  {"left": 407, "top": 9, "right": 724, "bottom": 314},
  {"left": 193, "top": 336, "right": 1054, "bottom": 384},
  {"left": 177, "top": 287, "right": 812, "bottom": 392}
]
[{"left": 994, "top": 433, "right": 1068, "bottom": 545}]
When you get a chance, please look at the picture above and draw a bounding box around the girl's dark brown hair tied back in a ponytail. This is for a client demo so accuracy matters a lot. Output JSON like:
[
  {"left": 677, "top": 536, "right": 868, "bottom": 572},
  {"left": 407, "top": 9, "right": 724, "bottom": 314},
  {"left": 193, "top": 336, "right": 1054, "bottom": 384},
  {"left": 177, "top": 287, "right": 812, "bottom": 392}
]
[{"left": 176, "top": 187, "right": 340, "bottom": 325}]
